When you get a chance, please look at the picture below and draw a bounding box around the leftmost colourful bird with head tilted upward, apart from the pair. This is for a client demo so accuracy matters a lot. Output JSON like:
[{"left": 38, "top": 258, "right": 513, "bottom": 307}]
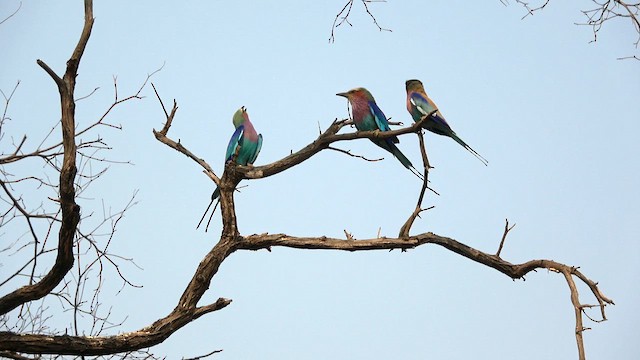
[{"left": 196, "top": 106, "right": 262, "bottom": 231}]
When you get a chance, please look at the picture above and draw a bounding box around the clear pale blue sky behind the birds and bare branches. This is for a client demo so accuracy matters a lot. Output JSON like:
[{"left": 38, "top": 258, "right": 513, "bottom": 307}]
[{"left": 0, "top": 0, "right": 640, "bottom": 359}]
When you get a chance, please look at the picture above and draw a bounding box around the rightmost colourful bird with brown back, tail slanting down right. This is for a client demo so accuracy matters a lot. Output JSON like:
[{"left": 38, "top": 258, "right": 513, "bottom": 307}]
[{"left": 405, "top": 79, "right": 489, "bottom": 166}]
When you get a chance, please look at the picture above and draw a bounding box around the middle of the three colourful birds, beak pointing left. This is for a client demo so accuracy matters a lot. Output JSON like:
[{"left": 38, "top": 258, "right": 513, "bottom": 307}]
[{"left": 336, "top": 87, "right": 423, "bottom": 179}]
